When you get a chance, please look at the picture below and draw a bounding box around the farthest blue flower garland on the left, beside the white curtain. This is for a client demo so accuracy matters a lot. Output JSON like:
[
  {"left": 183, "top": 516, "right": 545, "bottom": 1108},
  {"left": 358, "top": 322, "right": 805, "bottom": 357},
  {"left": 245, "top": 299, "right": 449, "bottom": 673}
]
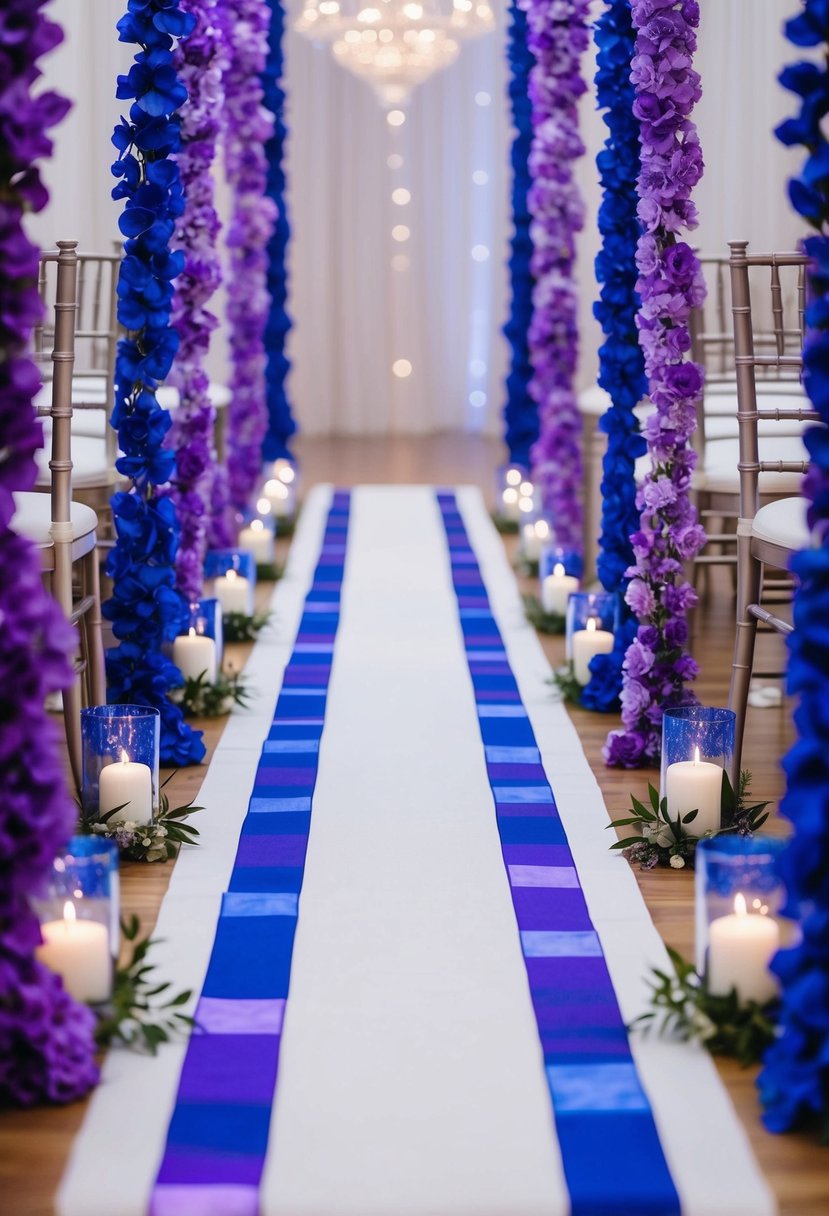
[{"left": 261, "top": 0, "right": 297, "bottom": 460}]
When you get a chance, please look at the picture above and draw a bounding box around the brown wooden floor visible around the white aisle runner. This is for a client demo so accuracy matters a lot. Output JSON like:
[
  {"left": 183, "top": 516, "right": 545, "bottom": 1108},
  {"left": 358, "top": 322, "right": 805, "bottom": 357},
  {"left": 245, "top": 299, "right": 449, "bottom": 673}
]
[{"left": 0, "top": 435, "right": 829, "bottom": 1216}]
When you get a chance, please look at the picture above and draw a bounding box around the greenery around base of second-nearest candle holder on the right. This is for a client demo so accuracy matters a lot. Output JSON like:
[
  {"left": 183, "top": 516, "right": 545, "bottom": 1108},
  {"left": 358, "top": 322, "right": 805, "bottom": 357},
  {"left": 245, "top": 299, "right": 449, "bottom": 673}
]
[{"left": 608, "top": 770, "right": 768, "bottom": 869}]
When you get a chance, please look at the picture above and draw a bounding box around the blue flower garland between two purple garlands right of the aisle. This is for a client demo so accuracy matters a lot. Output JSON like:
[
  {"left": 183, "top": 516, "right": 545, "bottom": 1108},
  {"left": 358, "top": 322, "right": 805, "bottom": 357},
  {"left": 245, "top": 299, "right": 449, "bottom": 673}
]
[{"left": 573, "top": 0, "right": 648, "bottom": 713}]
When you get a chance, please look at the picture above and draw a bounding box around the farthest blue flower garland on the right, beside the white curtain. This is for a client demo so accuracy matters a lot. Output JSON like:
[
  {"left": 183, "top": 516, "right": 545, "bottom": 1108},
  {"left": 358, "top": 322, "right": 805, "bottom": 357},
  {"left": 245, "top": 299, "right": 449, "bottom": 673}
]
[{"left": 503, "top": 0, "right": 538, "bottom": 468}]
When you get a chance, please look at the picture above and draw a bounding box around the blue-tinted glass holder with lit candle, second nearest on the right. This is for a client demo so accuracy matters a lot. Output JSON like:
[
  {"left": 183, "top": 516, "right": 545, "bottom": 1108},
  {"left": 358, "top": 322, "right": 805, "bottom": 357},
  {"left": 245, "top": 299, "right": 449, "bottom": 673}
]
[{"left": 659, "top": 705, "right": 737, "bottom": 837}]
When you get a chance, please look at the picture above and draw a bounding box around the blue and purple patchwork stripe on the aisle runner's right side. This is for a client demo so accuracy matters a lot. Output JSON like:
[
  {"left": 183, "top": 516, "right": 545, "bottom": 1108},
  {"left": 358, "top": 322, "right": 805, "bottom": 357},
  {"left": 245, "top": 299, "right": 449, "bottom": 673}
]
[{"left": 438, "top": 492, "right": 679, "bottom": 1216}]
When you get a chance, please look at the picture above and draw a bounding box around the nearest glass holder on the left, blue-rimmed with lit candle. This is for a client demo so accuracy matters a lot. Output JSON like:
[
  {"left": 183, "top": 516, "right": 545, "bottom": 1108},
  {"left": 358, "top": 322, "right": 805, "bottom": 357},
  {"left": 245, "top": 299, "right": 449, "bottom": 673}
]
[{"left": 33, "top": 837, "right": 120, "bottom": 1004}]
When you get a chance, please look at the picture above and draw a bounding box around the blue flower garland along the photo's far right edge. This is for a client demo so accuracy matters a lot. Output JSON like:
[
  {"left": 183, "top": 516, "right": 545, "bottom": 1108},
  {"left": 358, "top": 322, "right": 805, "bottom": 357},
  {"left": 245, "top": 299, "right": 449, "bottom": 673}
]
[{"left": 757, "top": 0, "right": 829, "bottom": 1139}]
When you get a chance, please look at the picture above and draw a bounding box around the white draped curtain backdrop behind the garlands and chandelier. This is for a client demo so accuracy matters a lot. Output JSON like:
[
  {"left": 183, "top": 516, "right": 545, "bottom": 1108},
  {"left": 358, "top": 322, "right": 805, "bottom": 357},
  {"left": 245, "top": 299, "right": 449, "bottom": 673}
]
[{"left": 30, "top": 0, "right": 802, "bottom": 434}]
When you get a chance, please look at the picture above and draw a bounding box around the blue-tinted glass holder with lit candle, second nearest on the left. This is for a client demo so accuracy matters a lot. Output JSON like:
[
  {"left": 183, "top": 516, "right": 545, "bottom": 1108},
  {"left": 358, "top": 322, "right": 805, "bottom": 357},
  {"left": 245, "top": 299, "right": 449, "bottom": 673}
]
[{"left": 80, "top": 705, "right": 160, "bottom": 823}]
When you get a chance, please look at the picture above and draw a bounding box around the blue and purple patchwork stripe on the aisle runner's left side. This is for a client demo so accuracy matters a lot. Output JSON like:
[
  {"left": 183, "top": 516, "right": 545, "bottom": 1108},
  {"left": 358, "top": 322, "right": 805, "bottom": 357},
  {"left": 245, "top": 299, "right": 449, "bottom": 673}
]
[{"left": 150, "top": 492, "right": 350, "bottom": 1216}]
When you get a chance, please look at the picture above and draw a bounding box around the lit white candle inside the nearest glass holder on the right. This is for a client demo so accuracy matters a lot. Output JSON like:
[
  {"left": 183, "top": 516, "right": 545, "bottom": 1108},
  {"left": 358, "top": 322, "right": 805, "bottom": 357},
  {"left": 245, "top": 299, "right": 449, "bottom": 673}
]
[{"left": 707, "top": 894, "right": 780, "bottom": 1004}]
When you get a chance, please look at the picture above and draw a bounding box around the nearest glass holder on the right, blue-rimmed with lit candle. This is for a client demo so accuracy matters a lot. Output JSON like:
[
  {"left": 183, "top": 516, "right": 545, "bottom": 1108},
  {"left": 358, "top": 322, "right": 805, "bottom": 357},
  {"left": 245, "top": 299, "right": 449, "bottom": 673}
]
[{"left": 695, "top": 835, "right": 785, "bottom": 1004}]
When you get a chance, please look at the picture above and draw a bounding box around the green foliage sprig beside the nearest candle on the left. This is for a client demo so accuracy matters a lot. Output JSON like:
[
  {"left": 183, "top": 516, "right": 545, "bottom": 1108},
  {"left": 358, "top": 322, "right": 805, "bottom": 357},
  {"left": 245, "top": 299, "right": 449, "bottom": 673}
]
[{"left": 95, "top": 916, "right": 196, "bottom": 1055}]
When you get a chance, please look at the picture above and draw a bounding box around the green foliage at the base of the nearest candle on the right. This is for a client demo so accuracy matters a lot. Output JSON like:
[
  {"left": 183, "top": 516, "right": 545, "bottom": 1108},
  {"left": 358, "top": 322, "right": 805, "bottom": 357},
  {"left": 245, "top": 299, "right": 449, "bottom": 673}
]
[{"left": 631, "top": 946, "right": 779, "bottom": 1068}]
